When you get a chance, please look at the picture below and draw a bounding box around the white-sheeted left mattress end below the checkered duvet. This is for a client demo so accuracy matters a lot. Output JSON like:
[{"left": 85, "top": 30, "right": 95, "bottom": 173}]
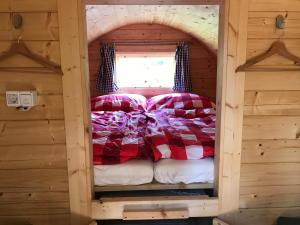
[{"left": 94, "top": 159, "right": 153, "bottom": 186}]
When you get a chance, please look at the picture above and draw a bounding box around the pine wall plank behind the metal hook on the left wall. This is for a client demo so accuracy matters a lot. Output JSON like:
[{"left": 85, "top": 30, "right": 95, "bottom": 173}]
[{"left": 0, "top": 12, "right": 59, "bottom": 41}]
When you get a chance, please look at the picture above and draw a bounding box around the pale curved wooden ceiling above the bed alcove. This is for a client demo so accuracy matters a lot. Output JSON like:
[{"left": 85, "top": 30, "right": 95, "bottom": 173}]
[{"left": 86, "top": 5, "right": 219, "bottom": 51}]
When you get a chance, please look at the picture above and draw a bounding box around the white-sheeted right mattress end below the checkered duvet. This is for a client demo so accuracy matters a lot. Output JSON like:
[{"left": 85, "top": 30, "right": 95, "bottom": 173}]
[{"left": 154, "top": 158, "right": 214, "bottom": 184}]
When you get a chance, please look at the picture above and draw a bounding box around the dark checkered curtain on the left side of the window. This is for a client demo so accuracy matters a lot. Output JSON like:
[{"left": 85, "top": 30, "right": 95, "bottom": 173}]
[{"left": 96, "top": 44, "right": 118, "bottom": 94}]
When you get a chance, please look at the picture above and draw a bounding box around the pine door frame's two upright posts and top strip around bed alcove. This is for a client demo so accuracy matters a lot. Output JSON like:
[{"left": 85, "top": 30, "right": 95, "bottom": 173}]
[{"left": 57, "top": 0, "right": 249, "bottom": 225}]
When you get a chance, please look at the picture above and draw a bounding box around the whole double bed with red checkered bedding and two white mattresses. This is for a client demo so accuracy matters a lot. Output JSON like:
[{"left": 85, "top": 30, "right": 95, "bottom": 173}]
[{"left": 92, "top": 93, "right": 215, "bottom": 191}]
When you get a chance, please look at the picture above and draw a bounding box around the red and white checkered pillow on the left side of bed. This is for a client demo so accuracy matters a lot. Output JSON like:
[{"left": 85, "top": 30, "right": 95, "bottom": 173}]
[{"left": 91, "top": 94, "right": 147, "bottom": 112}]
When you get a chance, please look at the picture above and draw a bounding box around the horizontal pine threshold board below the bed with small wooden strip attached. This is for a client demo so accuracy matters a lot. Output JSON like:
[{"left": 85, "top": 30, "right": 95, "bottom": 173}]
[{"left": 92, "top": 195, "right": 219, "bottom": 220}]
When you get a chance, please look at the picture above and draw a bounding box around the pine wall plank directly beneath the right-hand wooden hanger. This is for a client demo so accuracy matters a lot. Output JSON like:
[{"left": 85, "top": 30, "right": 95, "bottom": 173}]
[{"left": 245, "top": 72, "right": 300, "bottom": 91}]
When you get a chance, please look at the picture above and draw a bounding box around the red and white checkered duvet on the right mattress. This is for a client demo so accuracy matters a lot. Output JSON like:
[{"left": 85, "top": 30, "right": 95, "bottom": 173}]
[{"left": 145, "top": 108, "right": 216, "bottom": 161}]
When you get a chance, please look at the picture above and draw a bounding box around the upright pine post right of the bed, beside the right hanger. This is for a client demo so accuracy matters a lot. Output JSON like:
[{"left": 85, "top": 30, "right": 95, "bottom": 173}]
[{"left": 215, "top": 0, "right": 249, "bottom": 223}]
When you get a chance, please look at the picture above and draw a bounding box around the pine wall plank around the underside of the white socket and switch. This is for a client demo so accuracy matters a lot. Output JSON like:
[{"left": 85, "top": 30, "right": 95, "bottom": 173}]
[{"left": 0, "top": 95, "right": 64, "bottom": 120}]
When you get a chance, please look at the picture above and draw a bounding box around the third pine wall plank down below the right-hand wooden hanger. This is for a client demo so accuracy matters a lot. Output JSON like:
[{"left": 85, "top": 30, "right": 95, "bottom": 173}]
[{"left": 243, "top": 116, "right": 300, "bottom": 140}]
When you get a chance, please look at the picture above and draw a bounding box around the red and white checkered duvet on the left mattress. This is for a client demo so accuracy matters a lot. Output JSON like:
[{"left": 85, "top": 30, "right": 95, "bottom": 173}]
[{"left": 92, "top": 111, "right": 148, "bottom": 165}]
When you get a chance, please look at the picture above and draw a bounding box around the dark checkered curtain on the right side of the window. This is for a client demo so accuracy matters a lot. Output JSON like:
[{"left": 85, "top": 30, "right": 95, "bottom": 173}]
[{"left": 173, "top": 43, "right": 192, "bottom": 92}]
